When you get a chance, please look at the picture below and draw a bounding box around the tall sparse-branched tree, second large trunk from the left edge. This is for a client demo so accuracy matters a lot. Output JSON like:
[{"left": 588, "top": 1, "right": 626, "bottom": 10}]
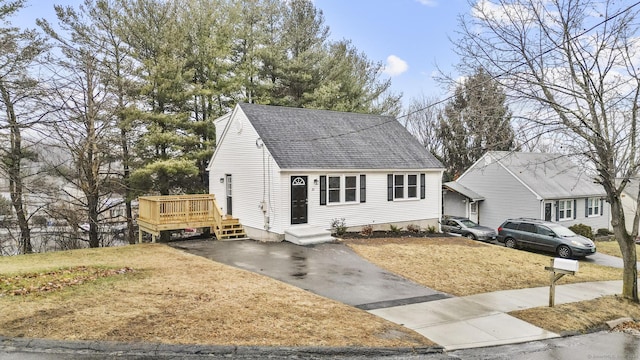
[{"left": 38, "top": 6, "right": 119, "bottom": 247}]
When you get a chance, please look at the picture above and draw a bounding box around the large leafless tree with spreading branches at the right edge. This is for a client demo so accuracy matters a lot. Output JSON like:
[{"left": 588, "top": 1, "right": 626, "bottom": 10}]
[{"left": 457, "top": 0, "right": 640, "bottom": 302}]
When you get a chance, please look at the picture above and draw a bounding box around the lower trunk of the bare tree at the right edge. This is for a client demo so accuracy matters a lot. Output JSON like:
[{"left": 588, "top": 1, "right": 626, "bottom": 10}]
[{"left": 611, "top": 199, "right": 639, "bottom": 302}]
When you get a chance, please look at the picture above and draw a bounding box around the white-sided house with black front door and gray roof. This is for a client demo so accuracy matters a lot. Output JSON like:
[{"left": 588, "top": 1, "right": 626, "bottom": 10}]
[{"left": 208, "top": 104, "right": 444, "bottom": 242}]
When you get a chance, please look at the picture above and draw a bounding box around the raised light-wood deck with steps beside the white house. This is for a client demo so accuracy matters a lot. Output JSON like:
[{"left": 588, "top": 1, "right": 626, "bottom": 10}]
[{"left": 137, "top": 194, "right": 246, "bottom": 242}]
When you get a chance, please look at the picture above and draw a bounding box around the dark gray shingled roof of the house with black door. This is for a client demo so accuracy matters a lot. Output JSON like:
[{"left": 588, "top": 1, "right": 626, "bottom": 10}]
[{"left": 239, "top": 104, "right": 442, "bottom": 169}]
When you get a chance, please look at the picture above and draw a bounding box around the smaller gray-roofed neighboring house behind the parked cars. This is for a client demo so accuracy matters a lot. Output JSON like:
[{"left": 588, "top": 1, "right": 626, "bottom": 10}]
[{"left": 444, "top": 151, "right": 610, "bottom": 231}]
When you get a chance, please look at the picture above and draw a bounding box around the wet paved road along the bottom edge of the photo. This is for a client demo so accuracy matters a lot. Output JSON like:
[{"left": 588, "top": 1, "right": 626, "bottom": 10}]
[{"left": 0, "top": 332, "right": 640, "bottom": 360}]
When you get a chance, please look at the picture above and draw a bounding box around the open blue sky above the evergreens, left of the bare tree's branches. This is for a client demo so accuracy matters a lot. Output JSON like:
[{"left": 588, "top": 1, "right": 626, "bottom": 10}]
[{"left": 12, "top": 0, "right": 470, "bottom": 105}]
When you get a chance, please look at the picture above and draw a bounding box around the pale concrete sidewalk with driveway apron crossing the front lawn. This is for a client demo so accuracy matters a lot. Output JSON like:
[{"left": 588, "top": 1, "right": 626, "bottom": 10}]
[{"left": 369, "top": 281, "right": 622, "bottom": 350}]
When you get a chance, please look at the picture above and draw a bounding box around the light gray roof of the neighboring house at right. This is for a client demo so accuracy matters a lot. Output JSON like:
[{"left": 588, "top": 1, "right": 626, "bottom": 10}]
[{"left": 487, "top": 151, "right": 606, "bottom": 199}]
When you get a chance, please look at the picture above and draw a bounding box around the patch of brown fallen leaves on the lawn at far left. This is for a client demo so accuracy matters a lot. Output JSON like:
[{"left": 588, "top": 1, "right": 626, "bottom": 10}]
[{"left": 0, "top": 266, "right": 134, "bottom": 296}]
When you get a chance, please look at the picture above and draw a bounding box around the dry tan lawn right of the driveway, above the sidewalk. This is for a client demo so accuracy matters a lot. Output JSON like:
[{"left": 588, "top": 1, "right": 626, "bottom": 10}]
[{"left": 346, "top": 237, "right": 622, "bottom": 296}]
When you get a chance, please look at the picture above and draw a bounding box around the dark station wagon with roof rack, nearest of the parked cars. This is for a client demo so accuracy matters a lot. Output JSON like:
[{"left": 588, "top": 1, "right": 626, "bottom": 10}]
[{"left": 498, "top": 218, "right": 596, "bottom": 258}]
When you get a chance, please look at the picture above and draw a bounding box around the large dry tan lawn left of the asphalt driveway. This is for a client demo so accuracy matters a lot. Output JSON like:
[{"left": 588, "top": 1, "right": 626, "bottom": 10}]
[{"left": 0, "top": 244, "right": 434, "bottom": 347}]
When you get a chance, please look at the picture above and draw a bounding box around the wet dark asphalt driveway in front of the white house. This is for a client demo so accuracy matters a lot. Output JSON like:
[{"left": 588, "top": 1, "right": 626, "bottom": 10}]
[{"left": 169, "top": 240, "right": 450, "bottom": 310}]
